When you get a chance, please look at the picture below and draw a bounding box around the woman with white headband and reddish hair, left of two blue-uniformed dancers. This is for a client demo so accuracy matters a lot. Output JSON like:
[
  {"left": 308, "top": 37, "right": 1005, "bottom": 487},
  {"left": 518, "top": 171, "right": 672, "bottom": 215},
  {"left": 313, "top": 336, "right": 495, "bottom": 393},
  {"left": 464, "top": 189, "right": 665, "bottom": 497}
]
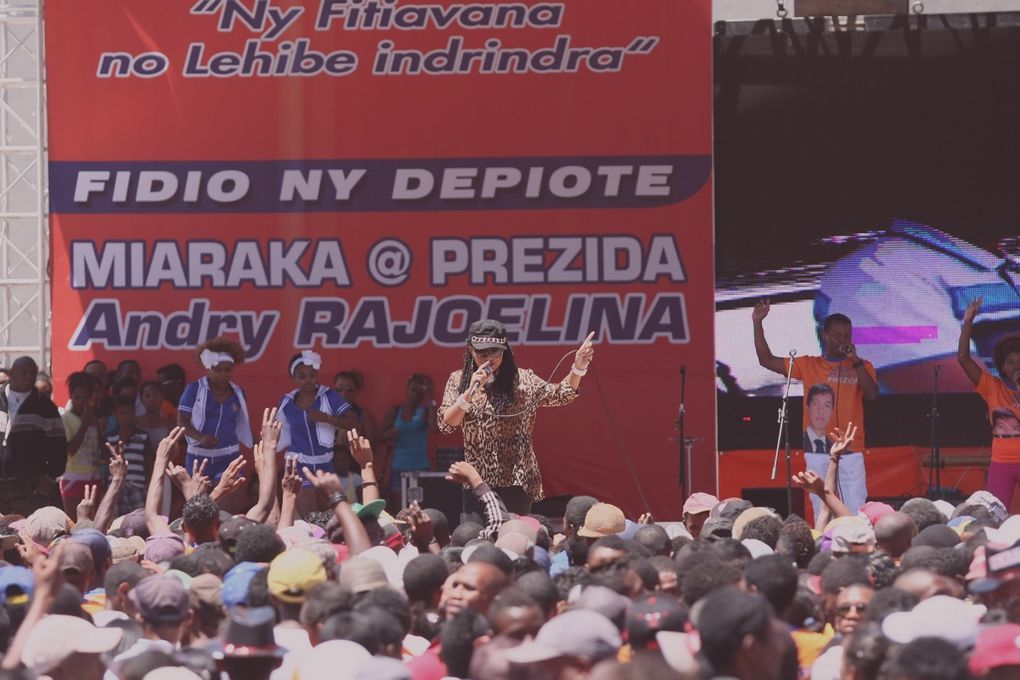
[{"left": 177, "top": 337, "right": 253, "bottom": 503}]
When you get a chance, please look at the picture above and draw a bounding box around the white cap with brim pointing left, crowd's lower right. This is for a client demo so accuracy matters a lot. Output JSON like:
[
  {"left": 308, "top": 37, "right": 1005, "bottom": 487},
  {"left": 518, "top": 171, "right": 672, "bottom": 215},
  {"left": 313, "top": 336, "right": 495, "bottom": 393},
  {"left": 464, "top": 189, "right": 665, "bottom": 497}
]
[{"left": 882, "top": 595, "right": 987, "bottom": 649}]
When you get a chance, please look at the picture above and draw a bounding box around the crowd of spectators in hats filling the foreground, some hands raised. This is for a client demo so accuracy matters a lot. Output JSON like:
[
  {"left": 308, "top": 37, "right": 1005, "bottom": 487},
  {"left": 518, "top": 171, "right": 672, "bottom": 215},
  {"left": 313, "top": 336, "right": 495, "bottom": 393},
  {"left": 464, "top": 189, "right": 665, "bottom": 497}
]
[{"left": 0, "top": 412, "right": 1020, "bottom": 680}]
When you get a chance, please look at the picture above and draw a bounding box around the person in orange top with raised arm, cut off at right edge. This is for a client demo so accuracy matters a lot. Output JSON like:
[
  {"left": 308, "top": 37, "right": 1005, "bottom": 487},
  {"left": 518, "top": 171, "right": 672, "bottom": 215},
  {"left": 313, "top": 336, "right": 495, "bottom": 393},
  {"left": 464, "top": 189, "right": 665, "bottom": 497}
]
[{"left": 957, "top": 298, "right": 1020, "bottom": 508}]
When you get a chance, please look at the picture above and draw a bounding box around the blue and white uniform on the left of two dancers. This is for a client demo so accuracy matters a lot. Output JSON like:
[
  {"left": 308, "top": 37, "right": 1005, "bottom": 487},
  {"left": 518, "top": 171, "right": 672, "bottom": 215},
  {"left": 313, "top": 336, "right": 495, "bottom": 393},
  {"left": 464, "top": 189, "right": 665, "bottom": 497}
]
[{"left": 177, "top": 377, "right": 254, "bottom": 483}]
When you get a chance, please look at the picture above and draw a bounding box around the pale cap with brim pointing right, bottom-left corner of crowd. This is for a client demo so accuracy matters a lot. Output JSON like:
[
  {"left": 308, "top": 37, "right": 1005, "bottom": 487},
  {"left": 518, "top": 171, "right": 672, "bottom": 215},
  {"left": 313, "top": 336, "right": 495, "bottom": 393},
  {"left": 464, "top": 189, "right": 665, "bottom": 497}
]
[{"left": 21, "top": 614, "right": 123, "bottom": 675}]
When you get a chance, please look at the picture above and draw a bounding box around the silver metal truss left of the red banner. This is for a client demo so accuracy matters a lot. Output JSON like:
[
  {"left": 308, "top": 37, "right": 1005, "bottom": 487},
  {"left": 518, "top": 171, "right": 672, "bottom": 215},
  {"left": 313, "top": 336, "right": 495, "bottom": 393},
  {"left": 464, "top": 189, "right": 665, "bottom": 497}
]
[{"left": 0, "top": 0, "right": 50, "bottom": 369}]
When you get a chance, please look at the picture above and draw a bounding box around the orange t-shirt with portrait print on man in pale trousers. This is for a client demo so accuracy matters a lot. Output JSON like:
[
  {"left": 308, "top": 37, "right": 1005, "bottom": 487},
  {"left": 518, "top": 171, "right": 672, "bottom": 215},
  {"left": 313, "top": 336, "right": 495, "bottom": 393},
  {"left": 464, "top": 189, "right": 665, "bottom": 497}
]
[{"left": 783, "top": 357, "right": 877, "bottom": 453}]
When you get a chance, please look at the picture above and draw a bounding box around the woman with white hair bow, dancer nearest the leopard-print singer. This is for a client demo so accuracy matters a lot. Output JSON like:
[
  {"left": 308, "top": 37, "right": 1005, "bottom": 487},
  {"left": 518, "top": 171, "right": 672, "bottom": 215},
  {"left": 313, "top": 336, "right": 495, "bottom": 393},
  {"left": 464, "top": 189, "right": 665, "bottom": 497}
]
[{"left": 276, "top": 350, "right": 357, "bottom": 515}]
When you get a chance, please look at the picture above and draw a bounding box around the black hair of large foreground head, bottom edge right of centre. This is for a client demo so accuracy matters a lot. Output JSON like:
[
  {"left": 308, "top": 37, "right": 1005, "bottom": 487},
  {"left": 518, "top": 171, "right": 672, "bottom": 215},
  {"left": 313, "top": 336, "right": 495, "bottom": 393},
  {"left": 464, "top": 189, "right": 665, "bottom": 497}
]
[{"left": 698, "top": 588, "right": 772, "bottom": 677}]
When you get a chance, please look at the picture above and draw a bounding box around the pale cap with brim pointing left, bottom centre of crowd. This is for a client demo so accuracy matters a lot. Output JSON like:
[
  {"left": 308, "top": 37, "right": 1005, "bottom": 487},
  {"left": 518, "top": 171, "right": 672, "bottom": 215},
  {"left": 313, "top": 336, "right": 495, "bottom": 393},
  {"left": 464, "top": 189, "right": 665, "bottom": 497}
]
[{"left": 506, "top": 610, "right": 623, "bottom": 664}]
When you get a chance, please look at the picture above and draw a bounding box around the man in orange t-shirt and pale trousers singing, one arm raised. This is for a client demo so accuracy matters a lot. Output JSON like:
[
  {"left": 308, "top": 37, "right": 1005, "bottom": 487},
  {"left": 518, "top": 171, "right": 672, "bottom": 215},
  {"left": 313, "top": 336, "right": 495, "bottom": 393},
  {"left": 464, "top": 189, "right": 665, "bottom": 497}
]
[{"left": 751, "top": 300, "right": 878, "bottom": 517}]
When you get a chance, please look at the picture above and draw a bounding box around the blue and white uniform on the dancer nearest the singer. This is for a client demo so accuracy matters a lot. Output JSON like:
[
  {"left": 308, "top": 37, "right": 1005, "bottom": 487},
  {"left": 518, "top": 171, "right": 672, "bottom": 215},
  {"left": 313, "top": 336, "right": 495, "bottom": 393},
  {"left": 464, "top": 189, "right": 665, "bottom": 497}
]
[{"left": 276, "top": 385, "right": 351, "bottom": 486}]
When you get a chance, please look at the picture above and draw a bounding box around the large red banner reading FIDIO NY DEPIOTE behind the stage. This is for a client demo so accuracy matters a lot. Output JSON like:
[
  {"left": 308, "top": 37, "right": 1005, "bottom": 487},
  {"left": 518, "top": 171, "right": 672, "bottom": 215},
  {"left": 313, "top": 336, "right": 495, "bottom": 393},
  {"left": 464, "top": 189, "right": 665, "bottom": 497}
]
[{"left": 46, "top": 0, "right": 715, "bottom": 518}]
